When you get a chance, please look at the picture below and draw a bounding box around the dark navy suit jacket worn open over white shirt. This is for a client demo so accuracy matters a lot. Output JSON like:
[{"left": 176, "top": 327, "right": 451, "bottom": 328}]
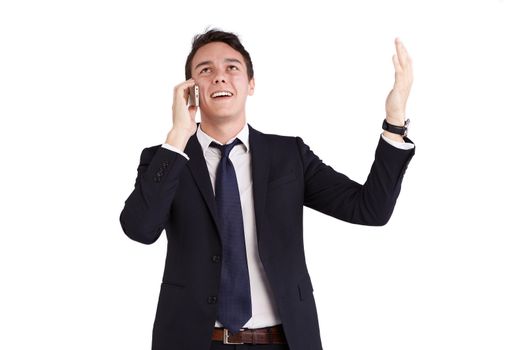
[{"left": 120, "top": 127, "right": 414, "bottom": 350}]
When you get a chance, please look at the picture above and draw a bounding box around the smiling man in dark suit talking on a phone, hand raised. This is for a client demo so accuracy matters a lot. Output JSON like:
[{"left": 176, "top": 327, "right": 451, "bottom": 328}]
[{"left": 120, "top": 30, "right": 414, "bottom": 350}]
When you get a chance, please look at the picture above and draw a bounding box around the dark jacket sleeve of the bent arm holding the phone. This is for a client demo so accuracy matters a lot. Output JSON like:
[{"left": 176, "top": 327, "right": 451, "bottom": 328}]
[{"left": 120, "top": 146, "right": 187, "bottom": 244}]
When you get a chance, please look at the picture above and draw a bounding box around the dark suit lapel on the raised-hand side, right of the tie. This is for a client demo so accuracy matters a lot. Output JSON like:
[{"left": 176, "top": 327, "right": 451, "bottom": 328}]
[{"left": 249, "top": 126, "right": 270, "bottom": 241}]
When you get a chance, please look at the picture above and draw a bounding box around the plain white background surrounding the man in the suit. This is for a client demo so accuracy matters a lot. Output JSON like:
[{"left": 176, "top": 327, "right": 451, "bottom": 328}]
[{"left": 0, "top": 0, "right": 525, "bottom": 350}]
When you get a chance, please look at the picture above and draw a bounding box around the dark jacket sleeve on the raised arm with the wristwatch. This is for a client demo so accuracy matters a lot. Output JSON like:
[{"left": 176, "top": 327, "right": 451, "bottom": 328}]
[{"left": 297, "top": 138, "right": 415, "bottom": 226}]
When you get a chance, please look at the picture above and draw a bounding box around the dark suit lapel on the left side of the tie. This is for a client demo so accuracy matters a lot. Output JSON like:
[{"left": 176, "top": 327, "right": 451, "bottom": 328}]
[{"left": 184, "top": 135, "right": 219, "bottom": 229}]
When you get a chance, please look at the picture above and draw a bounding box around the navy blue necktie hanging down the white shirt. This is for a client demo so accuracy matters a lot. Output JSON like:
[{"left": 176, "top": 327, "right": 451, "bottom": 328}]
[{"left": 211, "top": 139, "right": 252, "bottom": 333}]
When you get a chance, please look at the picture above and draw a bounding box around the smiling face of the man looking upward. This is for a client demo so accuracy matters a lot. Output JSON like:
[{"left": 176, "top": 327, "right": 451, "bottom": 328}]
[{"left": 191, "top": 42, "right": 255, "bottom": 122}]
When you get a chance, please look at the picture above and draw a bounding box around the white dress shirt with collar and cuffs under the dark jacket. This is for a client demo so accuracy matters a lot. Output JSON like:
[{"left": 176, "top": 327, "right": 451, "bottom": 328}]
[{"left": 162, "top": 124, "right": 414, "bottom": 328}]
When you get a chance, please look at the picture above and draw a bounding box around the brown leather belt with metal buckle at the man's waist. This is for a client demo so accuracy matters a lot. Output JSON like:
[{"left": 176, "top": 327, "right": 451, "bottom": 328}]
[{"left": 211, "top": 325, "right": 286, "bottom": 344}]
